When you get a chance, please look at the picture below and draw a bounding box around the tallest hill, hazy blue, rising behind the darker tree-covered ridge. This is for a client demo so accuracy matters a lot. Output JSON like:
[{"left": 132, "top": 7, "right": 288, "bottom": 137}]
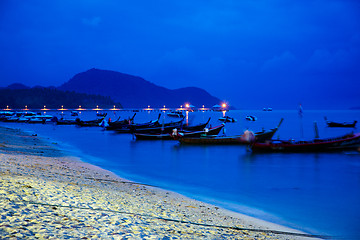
[{"left": 58, "top": 68, "right": 220, "bottom": 108}]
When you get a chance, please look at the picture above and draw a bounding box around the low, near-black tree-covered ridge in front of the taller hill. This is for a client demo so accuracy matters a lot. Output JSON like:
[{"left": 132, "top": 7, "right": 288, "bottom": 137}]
[{"left": 0, "top": 88, "right": 122, "bottom": 109}]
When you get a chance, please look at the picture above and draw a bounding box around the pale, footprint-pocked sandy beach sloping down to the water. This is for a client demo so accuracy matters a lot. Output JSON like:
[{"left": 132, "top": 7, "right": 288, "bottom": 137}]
[{"left": 0, "top": 127, "right": 320, "bottom": 239}]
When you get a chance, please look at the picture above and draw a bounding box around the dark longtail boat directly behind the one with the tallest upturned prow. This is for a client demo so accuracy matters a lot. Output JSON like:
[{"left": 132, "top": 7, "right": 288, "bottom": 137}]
[{"left": 135, "top": 123, "right": 225, "bottom": 140}]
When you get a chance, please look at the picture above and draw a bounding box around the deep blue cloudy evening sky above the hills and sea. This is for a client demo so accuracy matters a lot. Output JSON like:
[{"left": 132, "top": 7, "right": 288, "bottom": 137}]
[{"left": 0, "top": 0, "right": 360, "bottom": 109}]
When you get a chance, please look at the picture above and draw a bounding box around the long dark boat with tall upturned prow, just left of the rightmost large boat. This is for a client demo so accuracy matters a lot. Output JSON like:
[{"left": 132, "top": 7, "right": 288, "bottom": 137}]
[{"left": 179, "top": 118, "right": 284, "bottom": 145}]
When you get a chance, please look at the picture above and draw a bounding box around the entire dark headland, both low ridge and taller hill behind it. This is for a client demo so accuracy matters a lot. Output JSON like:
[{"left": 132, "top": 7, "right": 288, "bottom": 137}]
[{"left": 0, "top": 68, "right": 221, "bottom": 109}]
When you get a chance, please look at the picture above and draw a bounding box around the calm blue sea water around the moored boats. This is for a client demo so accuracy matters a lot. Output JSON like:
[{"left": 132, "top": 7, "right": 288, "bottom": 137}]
[{"left": 1, "top": 110, "right": 360, "bottom": 239}]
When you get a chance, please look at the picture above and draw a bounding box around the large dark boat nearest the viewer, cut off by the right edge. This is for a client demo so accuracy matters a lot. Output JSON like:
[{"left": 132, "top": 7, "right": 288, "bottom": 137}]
[{"left": 251, "top": 133, "right": 360, "bottom": 152}]
